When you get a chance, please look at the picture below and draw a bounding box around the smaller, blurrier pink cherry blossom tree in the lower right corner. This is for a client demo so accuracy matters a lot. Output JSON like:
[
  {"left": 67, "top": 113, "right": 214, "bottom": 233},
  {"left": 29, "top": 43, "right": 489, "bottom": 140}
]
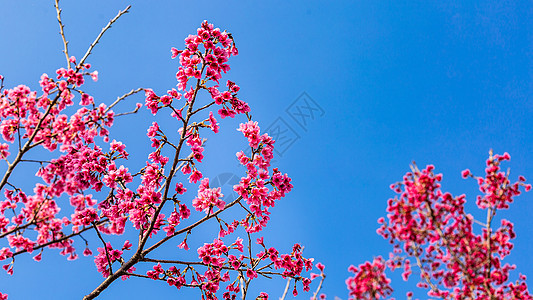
[{"left": 346, "top": 151, "right": 533, "bottom": 299}]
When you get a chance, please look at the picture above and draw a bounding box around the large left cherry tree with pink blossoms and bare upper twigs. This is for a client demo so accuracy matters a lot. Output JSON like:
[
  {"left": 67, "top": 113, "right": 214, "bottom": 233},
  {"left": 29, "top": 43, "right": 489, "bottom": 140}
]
[{"left": 0, "top": 0, "right": 324, "bottom": 299}]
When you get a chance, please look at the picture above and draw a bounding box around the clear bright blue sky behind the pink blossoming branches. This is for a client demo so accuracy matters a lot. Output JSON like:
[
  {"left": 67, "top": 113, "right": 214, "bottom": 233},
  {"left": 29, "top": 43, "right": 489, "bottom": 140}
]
[{"left": 0, "top": 0, "right": 533, "bottom": 299}]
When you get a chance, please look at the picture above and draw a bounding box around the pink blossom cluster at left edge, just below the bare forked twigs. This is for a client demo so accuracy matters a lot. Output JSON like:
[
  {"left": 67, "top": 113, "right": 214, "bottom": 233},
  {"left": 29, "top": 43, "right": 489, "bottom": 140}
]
[{"left": 0, "top": 64, "right": 114, "bottom": 151}]
